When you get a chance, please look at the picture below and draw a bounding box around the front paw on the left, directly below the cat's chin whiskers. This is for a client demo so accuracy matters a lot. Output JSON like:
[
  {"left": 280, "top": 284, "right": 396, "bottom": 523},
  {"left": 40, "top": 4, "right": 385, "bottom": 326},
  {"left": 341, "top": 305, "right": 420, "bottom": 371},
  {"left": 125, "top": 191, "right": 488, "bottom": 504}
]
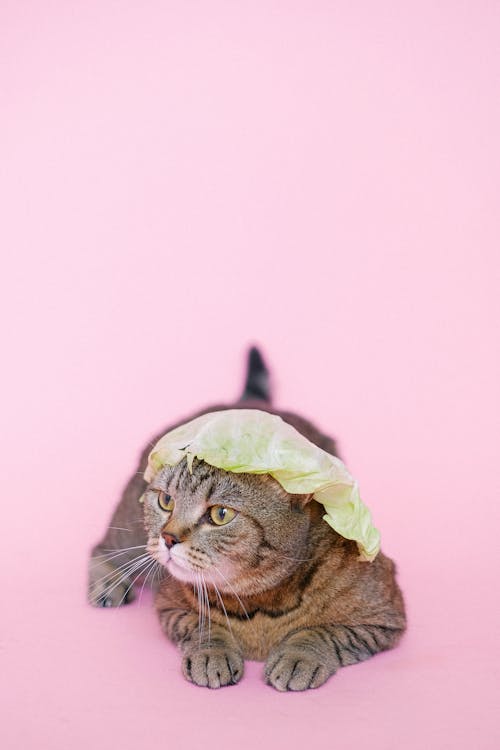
[{"left": 182, "top": 646, "right": 244, "bottom": 688}]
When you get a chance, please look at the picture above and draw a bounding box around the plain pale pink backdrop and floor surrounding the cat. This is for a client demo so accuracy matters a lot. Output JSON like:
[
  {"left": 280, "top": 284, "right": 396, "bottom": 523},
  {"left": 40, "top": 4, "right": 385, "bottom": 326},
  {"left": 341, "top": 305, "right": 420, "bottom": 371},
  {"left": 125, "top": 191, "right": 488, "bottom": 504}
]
[{"left": 0, "top": 0, "right": 500, "bottom": 750}]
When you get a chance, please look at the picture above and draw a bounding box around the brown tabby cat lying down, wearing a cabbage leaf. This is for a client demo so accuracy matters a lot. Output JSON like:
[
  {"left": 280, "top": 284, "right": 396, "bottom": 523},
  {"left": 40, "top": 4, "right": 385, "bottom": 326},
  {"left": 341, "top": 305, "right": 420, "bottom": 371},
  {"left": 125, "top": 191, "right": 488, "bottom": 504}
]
[{"left": 88, "top": 348, "right": 406, "bottom": 691}]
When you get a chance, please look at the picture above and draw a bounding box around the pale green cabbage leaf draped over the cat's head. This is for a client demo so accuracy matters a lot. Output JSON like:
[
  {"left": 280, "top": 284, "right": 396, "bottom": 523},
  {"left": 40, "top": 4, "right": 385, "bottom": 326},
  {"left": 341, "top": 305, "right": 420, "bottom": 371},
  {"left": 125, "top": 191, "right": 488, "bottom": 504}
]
[{"left": 144, "top": 409, "right": 380, "bottom": 561}]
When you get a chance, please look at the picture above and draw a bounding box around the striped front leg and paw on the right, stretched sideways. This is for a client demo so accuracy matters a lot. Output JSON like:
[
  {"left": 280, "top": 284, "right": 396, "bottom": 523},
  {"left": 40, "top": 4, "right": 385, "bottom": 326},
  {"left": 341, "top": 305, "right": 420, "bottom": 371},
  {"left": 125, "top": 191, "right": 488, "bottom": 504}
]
[{"left": 264, "top": 625, "right": 403, "bottom": 691}]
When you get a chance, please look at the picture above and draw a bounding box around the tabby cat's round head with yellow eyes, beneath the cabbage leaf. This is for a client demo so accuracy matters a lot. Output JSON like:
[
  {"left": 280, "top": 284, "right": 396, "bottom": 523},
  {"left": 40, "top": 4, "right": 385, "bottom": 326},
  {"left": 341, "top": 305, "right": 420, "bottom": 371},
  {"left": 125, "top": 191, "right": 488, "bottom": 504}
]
[{"left": 144, "top": 460, "right": 311, "bottom": 594}]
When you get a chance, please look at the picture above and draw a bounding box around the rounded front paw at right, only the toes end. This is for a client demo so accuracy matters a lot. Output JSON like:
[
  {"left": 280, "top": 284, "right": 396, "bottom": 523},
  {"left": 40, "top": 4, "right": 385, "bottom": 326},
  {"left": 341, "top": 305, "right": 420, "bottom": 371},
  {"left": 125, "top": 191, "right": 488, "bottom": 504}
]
[{"left": 264, "top": 647, "right": 332, "bottom": 692}]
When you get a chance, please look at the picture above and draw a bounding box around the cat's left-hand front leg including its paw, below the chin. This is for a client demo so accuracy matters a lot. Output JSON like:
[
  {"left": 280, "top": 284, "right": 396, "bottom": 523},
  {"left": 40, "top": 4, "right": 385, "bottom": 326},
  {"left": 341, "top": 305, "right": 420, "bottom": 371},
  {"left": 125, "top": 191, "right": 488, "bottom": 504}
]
[{"left": 158, "top": 607, "right": 244, "bottom": 688}]
